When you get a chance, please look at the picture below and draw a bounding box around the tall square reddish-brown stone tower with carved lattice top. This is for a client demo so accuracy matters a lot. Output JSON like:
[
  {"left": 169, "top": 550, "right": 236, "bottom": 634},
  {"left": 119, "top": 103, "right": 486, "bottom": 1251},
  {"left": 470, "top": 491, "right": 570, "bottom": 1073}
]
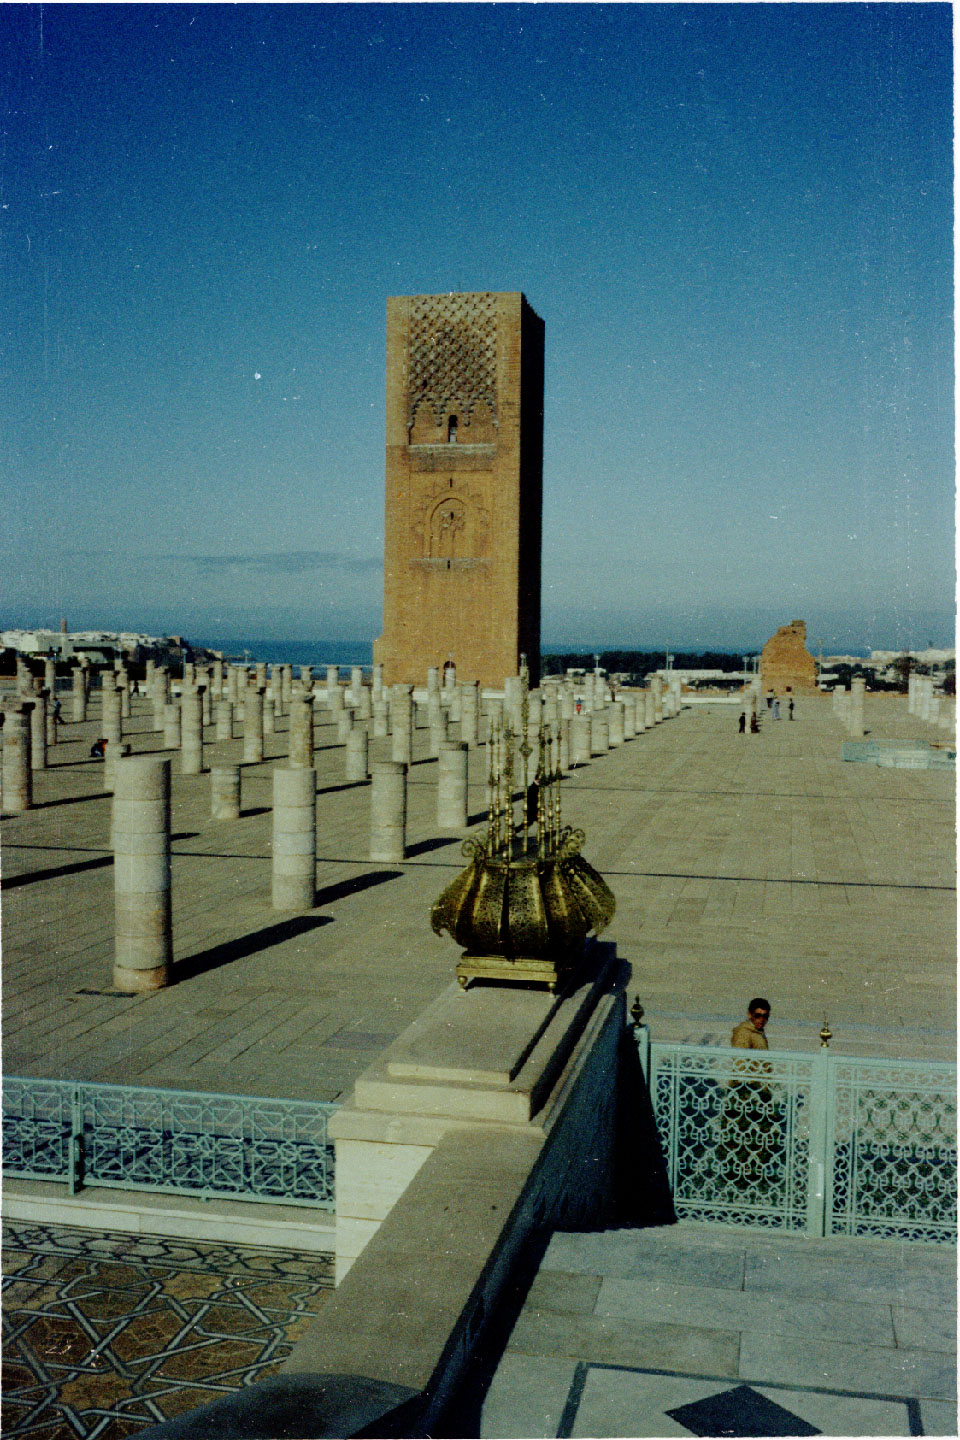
[{"left": 374, "top": 294, "right": 544, "bottom": 685}]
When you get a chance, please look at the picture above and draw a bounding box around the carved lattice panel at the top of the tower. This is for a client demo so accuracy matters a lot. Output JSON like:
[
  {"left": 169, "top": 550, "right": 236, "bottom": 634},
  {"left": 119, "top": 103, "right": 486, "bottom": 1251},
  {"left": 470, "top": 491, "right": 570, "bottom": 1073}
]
[{"left": 407, "top": 294, "right": 497, "bottom": 428}]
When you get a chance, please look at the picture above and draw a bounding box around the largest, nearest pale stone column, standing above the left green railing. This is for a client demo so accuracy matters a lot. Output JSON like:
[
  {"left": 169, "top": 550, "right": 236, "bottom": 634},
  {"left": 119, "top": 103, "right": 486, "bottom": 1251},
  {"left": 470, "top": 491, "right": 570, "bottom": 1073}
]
[{"left": 112, "top": 755, "right": 173, "bottom": 991}]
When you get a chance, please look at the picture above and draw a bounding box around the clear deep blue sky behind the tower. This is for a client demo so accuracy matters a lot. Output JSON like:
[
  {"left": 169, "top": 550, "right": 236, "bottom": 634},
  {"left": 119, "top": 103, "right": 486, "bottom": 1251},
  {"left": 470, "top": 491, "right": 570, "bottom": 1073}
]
[{"left": 0, "top": 3, "right": 954, "bottom": 649}]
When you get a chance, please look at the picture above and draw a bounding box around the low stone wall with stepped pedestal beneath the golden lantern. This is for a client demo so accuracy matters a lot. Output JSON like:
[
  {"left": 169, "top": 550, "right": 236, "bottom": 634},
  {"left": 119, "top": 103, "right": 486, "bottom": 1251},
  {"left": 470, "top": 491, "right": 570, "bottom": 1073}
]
[{"left": 138, "top": 946, "right": 626, "bottom": 1440}]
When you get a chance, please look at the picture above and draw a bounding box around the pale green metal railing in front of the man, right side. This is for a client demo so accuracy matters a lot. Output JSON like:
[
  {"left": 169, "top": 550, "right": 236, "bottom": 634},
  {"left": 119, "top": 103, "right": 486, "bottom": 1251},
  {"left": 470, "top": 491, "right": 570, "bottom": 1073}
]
[{"left": 639, "top": 1027, "right": 957, "bottom": 1244}]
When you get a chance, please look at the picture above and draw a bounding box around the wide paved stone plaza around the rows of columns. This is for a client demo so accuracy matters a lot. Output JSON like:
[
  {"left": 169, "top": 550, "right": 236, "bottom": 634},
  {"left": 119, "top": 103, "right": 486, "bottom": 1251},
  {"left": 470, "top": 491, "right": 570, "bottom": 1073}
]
[{"left": 3, "top": 696, "right": 956, "bottom": 1100}]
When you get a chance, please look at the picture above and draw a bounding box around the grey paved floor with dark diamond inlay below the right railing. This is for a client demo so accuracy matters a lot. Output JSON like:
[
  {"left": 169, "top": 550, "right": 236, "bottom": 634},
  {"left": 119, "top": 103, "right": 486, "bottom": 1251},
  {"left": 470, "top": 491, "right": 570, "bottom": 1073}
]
[{"left": 481, "top": 1224, "right": 957, "bottom": 1440}]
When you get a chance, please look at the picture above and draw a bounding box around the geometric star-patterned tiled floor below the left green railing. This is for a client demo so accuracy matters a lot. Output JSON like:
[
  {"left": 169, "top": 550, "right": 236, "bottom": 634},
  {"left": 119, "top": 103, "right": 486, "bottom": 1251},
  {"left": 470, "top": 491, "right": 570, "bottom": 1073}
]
[{"left": 0, "top": 1221, "right": 332, "bottom": 1440}]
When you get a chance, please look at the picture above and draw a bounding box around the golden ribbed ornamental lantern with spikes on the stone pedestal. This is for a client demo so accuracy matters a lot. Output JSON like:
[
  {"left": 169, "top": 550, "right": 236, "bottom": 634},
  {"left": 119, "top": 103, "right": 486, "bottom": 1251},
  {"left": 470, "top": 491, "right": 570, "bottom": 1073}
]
[{"left": 430, "top": 672, "right": 616, "bottom": 992}]
